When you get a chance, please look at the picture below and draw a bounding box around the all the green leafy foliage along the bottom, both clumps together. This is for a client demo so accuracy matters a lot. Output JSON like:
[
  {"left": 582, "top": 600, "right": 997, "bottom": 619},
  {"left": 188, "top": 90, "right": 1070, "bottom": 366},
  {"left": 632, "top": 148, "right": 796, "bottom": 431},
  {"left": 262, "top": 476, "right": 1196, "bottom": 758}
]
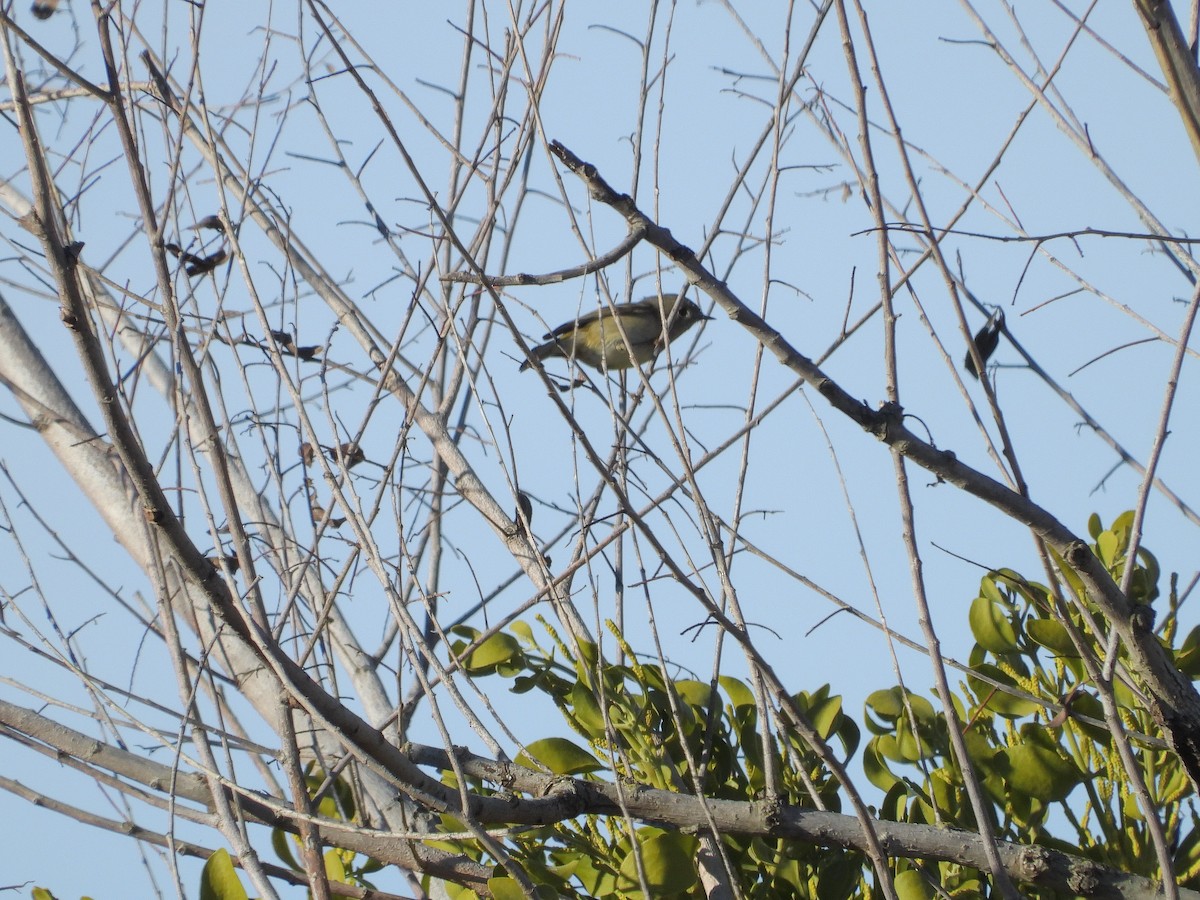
[{"left": 171, "top": 514, "right": 1200, "bottom": 900}]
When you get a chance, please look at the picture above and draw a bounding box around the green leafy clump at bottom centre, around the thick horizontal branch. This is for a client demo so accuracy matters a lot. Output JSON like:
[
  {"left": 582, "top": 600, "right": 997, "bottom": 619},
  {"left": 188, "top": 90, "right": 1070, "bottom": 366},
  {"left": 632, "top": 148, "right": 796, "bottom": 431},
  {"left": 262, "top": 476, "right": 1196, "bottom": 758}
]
[{"left": 437, "top": 623, "right": 863, "bottom": 900}]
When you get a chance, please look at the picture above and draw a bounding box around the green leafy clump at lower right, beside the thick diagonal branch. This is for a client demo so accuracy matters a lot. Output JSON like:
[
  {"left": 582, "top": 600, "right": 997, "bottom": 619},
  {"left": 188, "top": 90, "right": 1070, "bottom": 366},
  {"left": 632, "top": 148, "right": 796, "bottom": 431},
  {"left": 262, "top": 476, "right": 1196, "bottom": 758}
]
[{"left": 864, "top": 512, "right": 1200, "bottom": 896}]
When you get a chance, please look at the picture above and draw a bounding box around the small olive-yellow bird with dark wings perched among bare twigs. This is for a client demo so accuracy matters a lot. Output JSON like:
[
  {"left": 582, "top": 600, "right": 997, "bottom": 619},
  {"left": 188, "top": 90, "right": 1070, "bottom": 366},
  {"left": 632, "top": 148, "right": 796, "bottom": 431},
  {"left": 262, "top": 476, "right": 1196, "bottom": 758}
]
[{"left": 521, "top": 294, "right": 712, "bottom": 372}]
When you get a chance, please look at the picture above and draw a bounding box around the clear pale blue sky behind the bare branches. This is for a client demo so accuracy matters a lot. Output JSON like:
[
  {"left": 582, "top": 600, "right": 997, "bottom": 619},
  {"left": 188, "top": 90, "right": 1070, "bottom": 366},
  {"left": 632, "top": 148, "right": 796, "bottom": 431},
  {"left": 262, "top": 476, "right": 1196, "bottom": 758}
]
[{"left": 0, "top": 0, "right": 1200, "bottom": 900}]
